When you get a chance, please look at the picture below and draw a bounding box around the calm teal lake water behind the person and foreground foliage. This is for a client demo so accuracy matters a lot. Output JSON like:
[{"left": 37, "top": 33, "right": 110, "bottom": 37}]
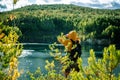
[{"left": 19, "top": 43, "right": 119, "bottom": 80}]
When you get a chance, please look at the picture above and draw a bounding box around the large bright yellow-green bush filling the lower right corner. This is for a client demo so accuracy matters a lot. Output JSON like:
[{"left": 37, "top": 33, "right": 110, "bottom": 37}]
[{"left": 84, "top": 45, "right": 120, "bottom": 80}]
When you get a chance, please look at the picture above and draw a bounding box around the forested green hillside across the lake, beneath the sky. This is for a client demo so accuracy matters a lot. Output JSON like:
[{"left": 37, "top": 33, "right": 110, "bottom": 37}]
[{"left": 0, "top": 4, "right": 120, "bottom": 44}]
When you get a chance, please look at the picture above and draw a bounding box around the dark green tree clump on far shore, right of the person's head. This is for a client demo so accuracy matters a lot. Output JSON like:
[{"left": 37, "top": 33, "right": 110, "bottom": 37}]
[{"left": 82, "top": 15, "right": 120, "bottom": 40}]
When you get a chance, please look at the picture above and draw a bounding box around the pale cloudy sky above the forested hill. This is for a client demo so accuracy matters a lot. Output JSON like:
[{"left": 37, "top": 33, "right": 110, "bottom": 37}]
[{"left": 0, "top": 0, "right": 120, "bottom": 12}]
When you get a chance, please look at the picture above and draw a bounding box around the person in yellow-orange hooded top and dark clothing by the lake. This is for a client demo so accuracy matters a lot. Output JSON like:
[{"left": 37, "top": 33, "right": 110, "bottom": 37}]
[{"left": 58, "top": 31, "right": 82, "bottom": 77}]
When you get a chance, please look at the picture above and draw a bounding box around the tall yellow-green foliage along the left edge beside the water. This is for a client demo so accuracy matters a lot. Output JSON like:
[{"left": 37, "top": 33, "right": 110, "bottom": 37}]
[{"left": 0, "top": 24, "right": 22, "bottom": 79}]
